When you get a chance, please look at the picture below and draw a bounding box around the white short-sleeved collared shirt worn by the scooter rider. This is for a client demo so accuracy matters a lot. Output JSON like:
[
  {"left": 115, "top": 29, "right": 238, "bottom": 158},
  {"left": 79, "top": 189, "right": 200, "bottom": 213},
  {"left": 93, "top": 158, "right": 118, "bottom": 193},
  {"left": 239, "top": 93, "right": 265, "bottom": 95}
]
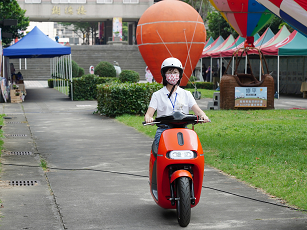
[{"left": 149, "top": 86, "right": 196, "bottom": 117}]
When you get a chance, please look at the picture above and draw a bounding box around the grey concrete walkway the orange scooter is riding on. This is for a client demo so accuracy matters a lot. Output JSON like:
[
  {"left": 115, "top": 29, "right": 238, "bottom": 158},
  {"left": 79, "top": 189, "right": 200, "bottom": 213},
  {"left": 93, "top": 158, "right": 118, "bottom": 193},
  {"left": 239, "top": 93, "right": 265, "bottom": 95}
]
[{"left": 0, "top": 87, "right": 307, "bottom": 230}]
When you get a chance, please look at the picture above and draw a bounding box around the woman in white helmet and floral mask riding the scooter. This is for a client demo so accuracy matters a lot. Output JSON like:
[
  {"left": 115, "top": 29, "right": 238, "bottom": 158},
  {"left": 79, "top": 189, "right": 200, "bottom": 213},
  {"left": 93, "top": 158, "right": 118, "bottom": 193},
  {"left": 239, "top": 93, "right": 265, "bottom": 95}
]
[{"left": 145, "top": 57, "right": 209, "bottom": 146}]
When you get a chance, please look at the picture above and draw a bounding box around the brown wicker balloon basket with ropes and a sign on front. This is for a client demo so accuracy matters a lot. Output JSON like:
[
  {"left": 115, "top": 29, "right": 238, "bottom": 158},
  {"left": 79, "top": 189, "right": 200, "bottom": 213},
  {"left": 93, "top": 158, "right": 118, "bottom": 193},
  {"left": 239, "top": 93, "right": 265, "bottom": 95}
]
[{"left": 220, "top": 47, "right": 275, "bottom": 110}]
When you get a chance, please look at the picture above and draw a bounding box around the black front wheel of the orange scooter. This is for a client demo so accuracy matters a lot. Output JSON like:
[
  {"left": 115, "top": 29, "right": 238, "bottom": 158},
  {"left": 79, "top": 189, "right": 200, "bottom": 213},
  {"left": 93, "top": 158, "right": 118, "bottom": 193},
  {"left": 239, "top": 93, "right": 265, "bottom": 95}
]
[{"left": 176, "top": 177, "right": 191, "bottom": 227}]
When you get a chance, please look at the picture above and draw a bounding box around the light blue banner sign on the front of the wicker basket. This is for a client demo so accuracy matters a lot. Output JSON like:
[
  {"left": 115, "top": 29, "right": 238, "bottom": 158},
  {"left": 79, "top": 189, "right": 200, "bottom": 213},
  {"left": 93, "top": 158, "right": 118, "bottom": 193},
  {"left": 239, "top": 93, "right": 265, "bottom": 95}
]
[{"left": 235, "top": 87, "right": 268, "bottom": 108}]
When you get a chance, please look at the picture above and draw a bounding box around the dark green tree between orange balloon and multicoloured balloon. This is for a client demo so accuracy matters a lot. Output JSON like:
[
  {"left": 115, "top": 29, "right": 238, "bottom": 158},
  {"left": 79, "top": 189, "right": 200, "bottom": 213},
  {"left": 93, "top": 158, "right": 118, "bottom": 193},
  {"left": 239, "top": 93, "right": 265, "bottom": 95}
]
[{"left": 207, "top": 11, "right": 238, "bottom": 40}]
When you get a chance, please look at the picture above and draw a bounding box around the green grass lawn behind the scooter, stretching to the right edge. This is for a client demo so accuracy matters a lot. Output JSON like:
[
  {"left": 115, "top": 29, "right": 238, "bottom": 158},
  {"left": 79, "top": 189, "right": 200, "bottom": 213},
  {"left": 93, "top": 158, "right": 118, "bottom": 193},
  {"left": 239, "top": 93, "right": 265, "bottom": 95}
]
[{"left": 116, "top": 110, "right": 307, "bottom": 210}]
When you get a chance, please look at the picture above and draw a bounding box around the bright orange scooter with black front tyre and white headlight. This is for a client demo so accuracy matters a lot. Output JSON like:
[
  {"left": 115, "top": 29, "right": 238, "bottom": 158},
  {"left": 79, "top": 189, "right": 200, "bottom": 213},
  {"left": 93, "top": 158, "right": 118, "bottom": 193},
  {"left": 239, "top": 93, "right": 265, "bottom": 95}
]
[{"left": 143, "top": 112, "right": 205, "bottom": 227}]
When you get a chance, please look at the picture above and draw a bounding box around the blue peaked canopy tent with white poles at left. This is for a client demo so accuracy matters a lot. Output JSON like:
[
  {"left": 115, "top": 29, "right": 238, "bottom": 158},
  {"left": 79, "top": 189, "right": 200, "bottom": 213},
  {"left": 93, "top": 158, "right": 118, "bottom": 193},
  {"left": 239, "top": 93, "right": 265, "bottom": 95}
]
[{"left": 3, "top": 26, "right": 73, "bottom": 100}]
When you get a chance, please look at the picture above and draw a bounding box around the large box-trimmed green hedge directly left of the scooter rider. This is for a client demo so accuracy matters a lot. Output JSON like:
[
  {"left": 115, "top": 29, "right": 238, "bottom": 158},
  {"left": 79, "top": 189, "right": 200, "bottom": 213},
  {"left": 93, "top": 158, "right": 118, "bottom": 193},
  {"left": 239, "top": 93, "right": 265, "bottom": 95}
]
[{"left": 97, "top": 83, "right": 163, "bottom": 117}]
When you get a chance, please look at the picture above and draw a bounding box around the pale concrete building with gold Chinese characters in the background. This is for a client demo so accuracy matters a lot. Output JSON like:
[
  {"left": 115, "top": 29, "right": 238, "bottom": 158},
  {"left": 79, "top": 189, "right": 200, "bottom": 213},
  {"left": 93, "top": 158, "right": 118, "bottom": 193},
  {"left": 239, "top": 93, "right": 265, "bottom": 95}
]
[{"left": 17, "top": 0, "right": 154, "bottom": 45}]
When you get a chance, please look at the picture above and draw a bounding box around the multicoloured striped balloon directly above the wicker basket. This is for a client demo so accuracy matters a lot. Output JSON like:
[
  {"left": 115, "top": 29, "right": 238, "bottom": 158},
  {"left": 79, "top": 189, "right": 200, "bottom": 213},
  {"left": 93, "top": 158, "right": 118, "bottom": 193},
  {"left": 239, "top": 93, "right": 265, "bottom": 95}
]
[{"left": 210, "top": 0, "right": 273, "bottom": 38}]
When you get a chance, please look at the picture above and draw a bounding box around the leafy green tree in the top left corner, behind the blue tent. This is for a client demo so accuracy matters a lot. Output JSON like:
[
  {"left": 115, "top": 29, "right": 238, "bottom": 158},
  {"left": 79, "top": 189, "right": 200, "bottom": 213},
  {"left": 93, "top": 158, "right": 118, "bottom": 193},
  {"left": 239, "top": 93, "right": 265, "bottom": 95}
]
[{"left": 0, "top": 0, "right": 30, "bottom": 45}]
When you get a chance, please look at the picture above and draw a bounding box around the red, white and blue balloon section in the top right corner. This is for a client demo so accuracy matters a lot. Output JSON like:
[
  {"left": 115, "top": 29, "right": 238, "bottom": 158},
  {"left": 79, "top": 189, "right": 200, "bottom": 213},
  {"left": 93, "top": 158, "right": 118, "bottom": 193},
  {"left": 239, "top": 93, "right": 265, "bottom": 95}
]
[{"left": 257, "top": 0, "right": 307, "bottom": 36}]
